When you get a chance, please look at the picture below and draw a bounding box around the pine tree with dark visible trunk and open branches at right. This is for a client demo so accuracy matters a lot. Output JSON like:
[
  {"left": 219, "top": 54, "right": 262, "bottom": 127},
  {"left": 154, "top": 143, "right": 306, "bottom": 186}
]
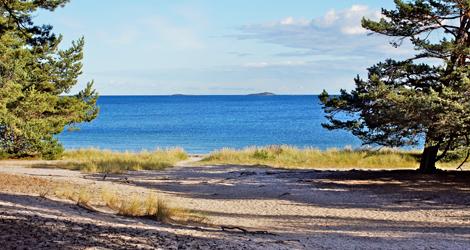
[{"left": 320, "top": 0, "right": 470, "bottom": 173}]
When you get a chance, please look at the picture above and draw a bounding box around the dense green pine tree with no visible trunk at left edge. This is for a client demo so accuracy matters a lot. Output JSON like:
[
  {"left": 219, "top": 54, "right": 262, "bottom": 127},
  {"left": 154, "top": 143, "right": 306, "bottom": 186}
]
[{"left": 0, "top": 0, "right": 98, "bottom": 158}]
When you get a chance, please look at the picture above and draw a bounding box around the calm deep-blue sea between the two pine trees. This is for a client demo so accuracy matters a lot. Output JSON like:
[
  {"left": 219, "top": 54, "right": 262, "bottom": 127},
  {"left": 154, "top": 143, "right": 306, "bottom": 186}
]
[{"left": 59, "top": 96, "right": 360, "bottom": 153}]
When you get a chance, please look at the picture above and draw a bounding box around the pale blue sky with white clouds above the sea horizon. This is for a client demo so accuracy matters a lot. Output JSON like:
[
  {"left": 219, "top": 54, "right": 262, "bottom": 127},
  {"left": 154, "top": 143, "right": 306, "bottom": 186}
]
[{"left": 35, "top": 0, "right": 411, "bottom": 95}]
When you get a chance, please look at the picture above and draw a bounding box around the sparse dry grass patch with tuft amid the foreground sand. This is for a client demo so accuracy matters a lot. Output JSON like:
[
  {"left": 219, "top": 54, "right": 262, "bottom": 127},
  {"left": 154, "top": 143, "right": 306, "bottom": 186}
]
[{"left": 0, "top": 173, "right": 206, "bottom": 224}]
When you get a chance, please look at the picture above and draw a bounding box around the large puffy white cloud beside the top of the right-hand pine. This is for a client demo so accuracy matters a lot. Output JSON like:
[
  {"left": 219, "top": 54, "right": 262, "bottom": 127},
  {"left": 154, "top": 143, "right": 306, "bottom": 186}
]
[{"left": 235, "top": 5, "right": 410, "bottom": 59}]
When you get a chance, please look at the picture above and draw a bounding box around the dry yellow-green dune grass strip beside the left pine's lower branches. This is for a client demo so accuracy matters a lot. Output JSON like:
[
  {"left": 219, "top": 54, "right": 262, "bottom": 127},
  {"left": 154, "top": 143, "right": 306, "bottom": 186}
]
[{"left": 35, "top": 148, "right": 188, "bottom": 173}]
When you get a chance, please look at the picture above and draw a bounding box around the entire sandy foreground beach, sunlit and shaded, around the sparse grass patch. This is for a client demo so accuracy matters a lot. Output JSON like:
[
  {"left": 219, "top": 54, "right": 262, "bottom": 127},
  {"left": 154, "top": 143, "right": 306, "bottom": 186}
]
[{"left": 0, "top": 159, "right": 470, "bottom": 249}]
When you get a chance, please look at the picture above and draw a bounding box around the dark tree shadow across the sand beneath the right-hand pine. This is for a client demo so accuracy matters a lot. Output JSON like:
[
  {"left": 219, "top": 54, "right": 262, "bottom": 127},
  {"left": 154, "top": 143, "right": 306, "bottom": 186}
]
[{"left": 87, "top": 165, "right": 470, "bottom": 211}]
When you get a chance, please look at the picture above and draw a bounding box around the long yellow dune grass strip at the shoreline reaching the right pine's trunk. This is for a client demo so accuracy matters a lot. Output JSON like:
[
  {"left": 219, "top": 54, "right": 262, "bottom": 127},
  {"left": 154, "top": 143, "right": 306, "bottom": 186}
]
[{"left": 201, "top": 146, "right": 464, "bottom": 169}]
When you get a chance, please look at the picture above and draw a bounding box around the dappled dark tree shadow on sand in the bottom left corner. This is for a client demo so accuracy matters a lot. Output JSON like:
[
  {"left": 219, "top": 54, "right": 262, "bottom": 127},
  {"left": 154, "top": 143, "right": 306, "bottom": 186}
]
[{"left": 0, "top": 193, "right": 272, "bottom": 249}]
